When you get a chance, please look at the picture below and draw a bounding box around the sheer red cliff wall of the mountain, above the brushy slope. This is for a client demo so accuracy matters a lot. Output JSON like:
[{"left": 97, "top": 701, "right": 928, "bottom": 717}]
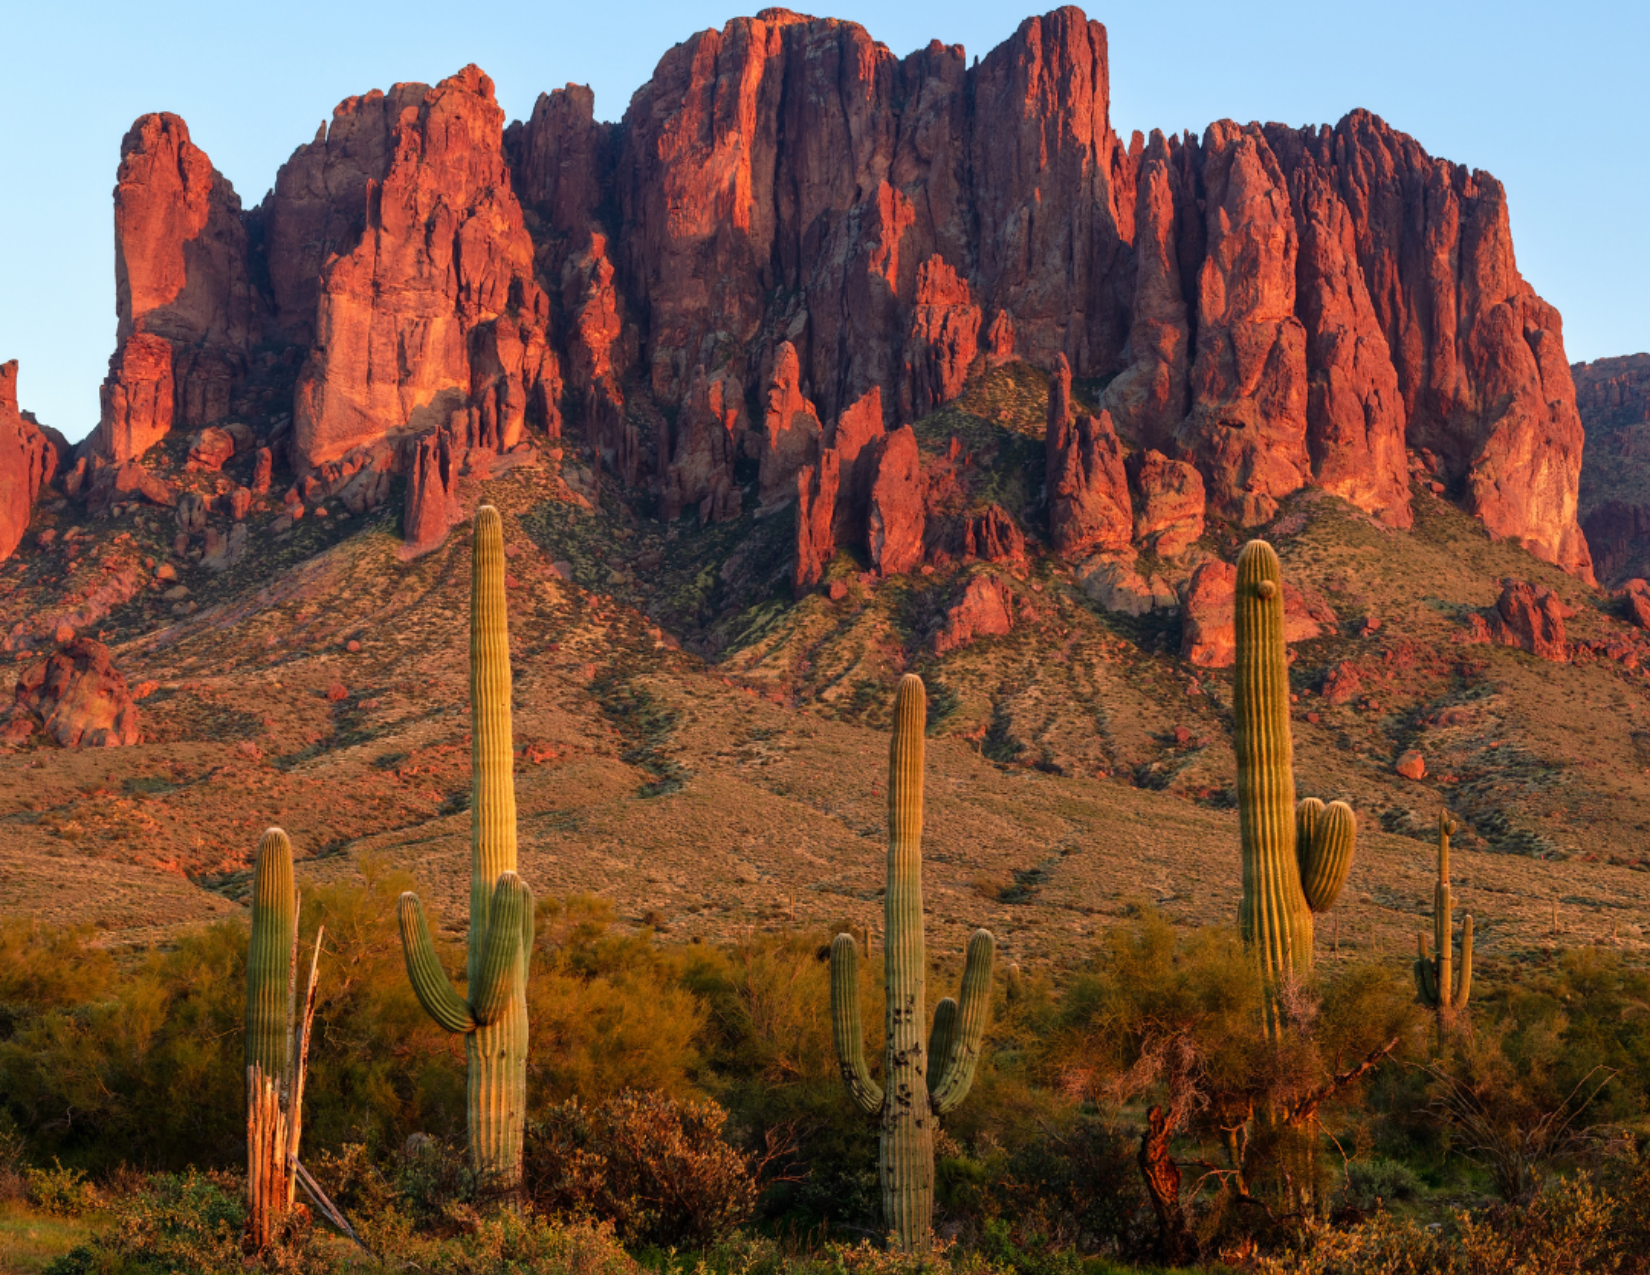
[{"left": 80, "top": 7, "right": 1591, "bottom": 581}]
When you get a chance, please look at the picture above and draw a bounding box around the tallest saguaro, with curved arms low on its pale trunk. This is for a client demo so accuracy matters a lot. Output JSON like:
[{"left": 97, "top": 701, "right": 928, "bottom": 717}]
[{"left": 398, "top": 505, "right": 533, "bottom": 1191}]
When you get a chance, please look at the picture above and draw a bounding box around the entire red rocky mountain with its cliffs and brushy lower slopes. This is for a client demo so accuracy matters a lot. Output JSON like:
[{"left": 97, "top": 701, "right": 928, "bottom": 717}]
[{"left": 0, "top": 8, "right": 1650, "bottom": 958}]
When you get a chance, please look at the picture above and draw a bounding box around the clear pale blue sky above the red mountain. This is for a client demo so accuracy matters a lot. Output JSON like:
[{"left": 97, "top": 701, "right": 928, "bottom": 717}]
[{"left": 0, "top": 0, "right": 1650, "bottom": 439}]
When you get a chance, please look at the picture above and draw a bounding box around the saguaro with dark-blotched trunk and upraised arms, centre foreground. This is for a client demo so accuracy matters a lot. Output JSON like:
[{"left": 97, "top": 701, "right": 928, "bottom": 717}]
[{"left": 830, "top": 675, "right": 995, "bottom": 1252}]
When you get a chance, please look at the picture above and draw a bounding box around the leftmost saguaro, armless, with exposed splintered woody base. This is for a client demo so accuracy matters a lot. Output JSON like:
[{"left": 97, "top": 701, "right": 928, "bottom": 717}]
[{"left": 246, "top": 828, "right": 322, "bottom": 1252}]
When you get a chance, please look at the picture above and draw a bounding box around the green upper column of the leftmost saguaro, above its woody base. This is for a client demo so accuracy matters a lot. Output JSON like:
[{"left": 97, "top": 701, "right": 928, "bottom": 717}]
[{"left": 246, "top": 828, "right": 299, "bottom": 1094}]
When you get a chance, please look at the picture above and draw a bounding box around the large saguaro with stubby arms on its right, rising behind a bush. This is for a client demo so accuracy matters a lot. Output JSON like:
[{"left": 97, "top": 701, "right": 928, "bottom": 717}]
[{"left": 1233, "top": 539, "right": 1356, "bottom": 1013}]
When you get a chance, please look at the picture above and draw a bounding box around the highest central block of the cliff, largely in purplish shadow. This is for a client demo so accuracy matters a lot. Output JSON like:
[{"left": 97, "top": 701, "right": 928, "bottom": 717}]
[{"left": 607, "top": 8, "right": 1134, "bottom": 422}]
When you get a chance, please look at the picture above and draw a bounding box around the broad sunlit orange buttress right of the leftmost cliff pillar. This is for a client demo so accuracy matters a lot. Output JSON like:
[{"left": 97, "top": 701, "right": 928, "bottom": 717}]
[{"left": 290, "top": 66, "right": 561, "bottom": 467}]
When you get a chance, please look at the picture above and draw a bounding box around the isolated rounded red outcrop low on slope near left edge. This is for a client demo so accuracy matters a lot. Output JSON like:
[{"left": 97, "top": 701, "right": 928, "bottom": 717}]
[{"left": 0, "top": 638, "right": 140, "bottom": 747}]
